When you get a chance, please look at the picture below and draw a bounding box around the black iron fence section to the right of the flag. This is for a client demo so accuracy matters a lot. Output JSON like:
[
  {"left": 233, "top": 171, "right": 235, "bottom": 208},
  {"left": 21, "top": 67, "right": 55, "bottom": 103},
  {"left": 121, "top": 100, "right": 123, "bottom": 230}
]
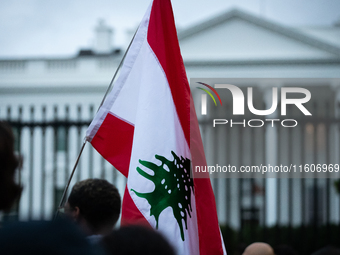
[{"left": 200, "top": 99, "right": 340, "bottom": 254}]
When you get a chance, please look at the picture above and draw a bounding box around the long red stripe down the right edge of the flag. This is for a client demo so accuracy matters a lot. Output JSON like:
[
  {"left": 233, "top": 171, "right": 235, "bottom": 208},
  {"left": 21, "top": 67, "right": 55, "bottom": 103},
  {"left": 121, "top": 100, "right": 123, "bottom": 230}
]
[{"left": 147, "top": 0, "right": 223, "bottom": 255}]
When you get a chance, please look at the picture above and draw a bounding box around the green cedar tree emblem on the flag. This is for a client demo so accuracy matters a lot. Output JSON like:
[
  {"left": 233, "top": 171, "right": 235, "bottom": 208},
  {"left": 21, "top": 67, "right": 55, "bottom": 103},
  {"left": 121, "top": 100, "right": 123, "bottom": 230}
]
[{"left": 131, "top": 151, "right": 194, "bottom": 241}]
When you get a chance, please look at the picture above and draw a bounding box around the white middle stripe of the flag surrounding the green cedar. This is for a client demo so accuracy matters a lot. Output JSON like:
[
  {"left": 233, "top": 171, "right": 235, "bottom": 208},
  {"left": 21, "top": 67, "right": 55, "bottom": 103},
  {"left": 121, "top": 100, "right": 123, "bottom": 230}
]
[{"left": 126, "top": 35, "right": 199, "bottom": 254}]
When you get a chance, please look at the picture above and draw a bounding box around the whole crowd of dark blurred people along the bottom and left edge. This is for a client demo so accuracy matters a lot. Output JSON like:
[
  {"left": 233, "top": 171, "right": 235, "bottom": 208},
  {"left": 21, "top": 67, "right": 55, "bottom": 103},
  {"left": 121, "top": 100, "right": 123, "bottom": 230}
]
[{"left": 0, "top": 121, "right": 340, "bottom": 255}]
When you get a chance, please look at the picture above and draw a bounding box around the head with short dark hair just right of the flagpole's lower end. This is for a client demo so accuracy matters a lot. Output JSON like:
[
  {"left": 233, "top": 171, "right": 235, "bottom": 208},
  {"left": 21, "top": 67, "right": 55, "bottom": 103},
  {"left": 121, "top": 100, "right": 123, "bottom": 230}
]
[{"left": 65, "top": 179, "right": 121, "bottom": 235}]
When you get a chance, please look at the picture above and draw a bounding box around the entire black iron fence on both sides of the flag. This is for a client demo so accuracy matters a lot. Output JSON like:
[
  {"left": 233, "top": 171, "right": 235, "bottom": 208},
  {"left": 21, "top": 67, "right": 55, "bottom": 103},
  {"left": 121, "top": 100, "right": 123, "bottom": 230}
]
[{"left": 0, "top": 102, "right": 340, "bottom": 254}]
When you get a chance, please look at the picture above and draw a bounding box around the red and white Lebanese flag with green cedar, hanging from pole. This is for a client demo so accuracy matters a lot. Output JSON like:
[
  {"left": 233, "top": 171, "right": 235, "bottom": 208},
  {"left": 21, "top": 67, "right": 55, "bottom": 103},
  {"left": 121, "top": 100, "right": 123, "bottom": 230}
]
[{"left": 87, "top": 0, "right": 226, "bottom": 255}]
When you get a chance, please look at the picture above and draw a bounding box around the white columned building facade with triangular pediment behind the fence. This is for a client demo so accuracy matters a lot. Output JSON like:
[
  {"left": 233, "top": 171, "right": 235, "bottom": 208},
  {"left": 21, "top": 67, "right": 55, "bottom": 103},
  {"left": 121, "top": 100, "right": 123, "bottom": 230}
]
[{"left": 0, "top": 10, "right": 340, "bottom": 228}]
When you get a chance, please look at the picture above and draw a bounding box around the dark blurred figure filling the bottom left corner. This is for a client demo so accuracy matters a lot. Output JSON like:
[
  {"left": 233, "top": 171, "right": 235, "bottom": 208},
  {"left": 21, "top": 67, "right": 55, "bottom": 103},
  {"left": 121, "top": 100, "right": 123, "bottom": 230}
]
[{"left": 0, "top": 219, "right": 105, "bottom": 255}]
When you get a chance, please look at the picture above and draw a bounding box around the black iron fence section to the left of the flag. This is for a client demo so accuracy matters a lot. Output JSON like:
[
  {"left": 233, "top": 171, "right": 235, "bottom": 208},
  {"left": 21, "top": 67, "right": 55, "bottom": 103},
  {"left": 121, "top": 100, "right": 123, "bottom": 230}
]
[{"left": 3, "top": 106, "right": 121, "bottom": 220}]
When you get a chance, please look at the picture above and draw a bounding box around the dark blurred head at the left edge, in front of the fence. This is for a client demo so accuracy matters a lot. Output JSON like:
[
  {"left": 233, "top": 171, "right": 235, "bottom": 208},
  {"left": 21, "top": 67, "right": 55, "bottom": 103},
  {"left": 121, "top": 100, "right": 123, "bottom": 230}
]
[{"left": 0, "top": 121, "right": 22, "bottom": 211}]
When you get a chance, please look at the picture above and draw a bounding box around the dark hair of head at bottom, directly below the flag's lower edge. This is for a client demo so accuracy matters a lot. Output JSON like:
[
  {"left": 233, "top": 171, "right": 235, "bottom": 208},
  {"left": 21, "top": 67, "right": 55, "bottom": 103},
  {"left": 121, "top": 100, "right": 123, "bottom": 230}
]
[{"left": 101, "top": 225, "right": 175, "bottom": 255}]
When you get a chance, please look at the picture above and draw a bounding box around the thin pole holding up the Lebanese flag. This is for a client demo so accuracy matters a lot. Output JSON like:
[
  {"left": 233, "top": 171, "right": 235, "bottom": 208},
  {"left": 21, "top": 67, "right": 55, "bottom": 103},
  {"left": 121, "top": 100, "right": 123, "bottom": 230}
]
[{"left": 54, "top": 28, "right": 138, "bottom": 219}]
